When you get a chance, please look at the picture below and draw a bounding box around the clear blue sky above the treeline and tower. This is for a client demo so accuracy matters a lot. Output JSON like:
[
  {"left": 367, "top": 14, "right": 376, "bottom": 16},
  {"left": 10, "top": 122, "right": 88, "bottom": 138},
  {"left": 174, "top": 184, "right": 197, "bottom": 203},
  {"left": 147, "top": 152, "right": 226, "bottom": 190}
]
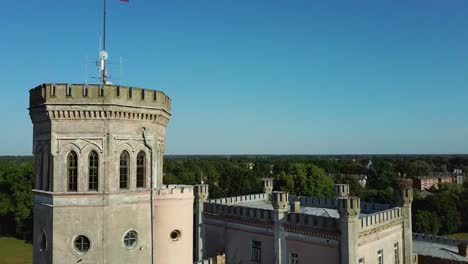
[{"left": 0, "top": 0, "right": 468, "bottom": 155}]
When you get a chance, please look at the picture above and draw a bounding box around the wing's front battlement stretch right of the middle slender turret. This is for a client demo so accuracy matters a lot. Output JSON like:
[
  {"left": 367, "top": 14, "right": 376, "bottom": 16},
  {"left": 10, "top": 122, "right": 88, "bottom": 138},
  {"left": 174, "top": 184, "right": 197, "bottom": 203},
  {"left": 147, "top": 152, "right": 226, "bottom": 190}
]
[{"left": 286, "top": 213, "right": 338, "bottom": 231}]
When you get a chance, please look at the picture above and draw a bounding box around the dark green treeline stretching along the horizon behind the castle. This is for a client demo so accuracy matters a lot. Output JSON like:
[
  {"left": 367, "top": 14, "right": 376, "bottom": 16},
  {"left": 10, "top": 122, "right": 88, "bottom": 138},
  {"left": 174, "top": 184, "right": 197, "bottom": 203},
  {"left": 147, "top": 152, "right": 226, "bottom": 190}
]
[{"left": 0, "top": 155, "right": 468, "bottom": 240}]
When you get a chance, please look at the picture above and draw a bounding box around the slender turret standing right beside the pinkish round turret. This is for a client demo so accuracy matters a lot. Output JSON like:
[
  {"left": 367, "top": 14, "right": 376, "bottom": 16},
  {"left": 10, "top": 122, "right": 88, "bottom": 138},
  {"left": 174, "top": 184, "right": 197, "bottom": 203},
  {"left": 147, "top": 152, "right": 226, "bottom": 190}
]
[{"left": 194, "top": 184, "right": 209, "bottom": 261}]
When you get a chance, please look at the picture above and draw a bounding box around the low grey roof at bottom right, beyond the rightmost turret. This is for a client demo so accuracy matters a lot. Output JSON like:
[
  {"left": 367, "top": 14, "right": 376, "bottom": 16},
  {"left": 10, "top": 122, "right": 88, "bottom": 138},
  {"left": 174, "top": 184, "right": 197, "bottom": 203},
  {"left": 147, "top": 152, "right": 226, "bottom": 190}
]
[{"left": 413, "top": 239, "right": 468, "bottom": 263}]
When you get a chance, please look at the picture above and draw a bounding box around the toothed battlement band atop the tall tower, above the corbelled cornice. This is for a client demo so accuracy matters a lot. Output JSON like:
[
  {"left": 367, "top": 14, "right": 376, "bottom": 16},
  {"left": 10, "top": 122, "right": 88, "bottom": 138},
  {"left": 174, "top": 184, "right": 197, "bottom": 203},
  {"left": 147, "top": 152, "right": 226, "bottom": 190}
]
[{"left": 29, "top": 83, "right": 171, "bottom": 113}]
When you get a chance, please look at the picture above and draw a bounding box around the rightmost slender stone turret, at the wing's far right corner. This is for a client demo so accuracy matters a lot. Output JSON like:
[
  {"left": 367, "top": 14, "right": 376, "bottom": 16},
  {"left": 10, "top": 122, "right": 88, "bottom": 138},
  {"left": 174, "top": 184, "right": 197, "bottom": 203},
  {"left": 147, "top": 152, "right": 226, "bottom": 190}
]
[{"left": 398, "top": 179, "right": 413, "bottom": 264}]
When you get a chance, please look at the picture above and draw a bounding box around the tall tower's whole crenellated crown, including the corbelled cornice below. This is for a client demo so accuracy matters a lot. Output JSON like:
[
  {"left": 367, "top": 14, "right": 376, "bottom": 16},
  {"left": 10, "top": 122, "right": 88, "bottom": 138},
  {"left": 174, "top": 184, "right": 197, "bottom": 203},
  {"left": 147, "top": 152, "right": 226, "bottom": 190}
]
[{"left": 29, "top": 83, "right": 171, "bottom": 124}]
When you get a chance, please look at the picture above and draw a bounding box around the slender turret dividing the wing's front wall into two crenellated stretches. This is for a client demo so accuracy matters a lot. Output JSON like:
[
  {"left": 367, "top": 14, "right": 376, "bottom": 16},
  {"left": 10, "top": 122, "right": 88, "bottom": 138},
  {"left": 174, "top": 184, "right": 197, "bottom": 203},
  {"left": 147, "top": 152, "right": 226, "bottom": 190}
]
[{"left": 271, "top": 191, "right": 289, "bottom": 264}]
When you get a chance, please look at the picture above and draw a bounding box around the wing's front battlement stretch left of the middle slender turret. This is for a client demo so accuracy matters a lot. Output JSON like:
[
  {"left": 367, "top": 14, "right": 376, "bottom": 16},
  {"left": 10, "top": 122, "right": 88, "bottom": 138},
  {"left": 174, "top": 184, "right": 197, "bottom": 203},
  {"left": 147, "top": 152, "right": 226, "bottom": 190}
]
[{"left": 203, "top": 203, "right": 273, "bottom": 221}]
